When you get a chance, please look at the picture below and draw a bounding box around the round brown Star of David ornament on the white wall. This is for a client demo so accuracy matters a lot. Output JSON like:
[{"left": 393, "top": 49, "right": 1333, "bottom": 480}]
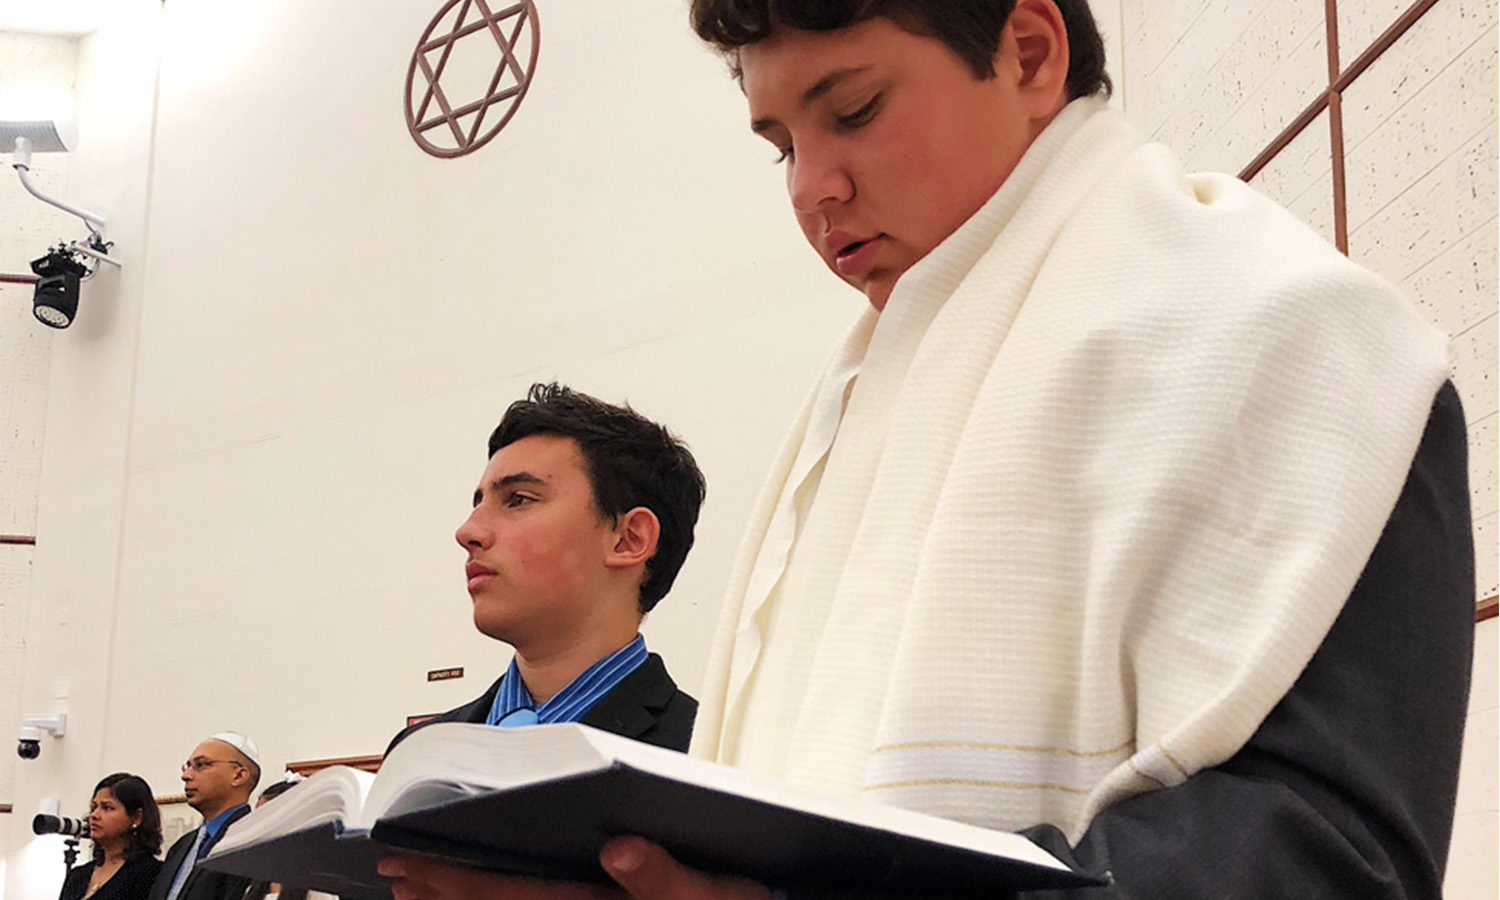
[{"left": 407, "top": 0, "right": 542, "bottom": 159}]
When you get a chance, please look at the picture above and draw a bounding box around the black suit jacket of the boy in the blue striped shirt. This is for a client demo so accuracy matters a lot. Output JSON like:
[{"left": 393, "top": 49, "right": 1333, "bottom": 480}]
[{"left": 384, "top": 653, "right": 698, "bottom": 756}]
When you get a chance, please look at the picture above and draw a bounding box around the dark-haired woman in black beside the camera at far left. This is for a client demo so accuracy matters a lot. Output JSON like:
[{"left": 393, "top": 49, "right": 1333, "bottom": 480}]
[{"left": 59, "top": 773, "right": 162, "bottom": 900}]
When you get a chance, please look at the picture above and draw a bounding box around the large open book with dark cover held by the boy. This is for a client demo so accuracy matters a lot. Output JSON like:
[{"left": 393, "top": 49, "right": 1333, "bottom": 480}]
[{"left": 200, "top": 723, "right": 1100, "bottom": 900}]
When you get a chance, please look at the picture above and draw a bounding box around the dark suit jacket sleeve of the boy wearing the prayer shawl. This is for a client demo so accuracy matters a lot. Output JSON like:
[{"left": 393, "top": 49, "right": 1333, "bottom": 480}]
[{"left": 1026, "top": 384, "right": 1475, "bottom": 900}]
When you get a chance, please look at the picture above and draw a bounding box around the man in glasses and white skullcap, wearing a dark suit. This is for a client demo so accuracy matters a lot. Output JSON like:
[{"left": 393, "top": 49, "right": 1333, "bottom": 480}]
[{"left": 147, "top": 732, "right": 261, "bottom": 900}]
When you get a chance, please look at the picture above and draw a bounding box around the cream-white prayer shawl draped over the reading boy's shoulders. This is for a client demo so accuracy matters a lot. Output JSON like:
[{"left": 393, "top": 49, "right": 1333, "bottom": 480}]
[{"left": 693, "top": 98, "right": 1448, "bottom": 840}]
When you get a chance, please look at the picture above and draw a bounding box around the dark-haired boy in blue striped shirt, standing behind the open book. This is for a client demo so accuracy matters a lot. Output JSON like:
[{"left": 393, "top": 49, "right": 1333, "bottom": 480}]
[{"left": 387, "top": 384, "right": 705, "bottom": 752}]
